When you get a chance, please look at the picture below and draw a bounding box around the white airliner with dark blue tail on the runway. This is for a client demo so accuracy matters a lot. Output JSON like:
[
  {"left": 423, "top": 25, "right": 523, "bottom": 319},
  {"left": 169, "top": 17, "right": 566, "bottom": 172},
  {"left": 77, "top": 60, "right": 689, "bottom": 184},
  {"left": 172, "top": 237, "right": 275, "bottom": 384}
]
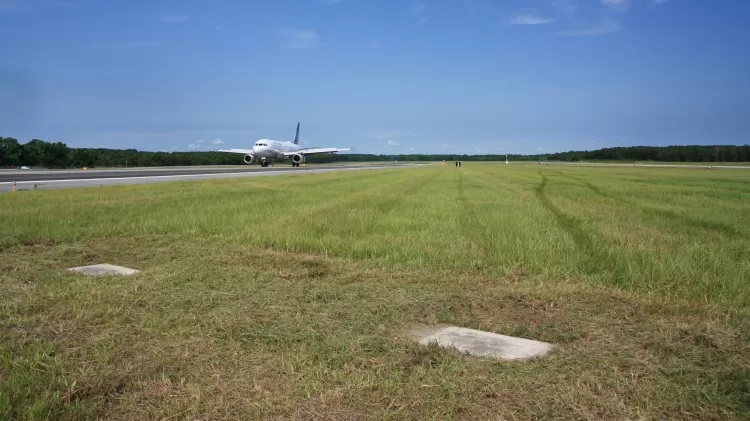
[{"left": 217, "top": 122, "right": 351, "bottom": 167}]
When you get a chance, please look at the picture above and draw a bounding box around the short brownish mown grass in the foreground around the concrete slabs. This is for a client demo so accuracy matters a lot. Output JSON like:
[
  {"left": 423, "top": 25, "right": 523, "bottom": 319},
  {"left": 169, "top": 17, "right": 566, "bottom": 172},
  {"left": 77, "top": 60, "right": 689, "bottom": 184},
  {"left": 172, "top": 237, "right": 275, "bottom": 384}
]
[{"left": 0, "top": 237, "right": 750, "bottom": 420}]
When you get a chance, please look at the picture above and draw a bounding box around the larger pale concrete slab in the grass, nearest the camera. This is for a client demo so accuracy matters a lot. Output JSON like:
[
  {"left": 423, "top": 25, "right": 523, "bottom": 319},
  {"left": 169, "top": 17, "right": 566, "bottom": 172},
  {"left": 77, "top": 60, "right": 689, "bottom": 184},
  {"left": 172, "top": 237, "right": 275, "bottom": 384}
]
[{"left": 412, "top": 326, "right": 552, "bottom": 360}]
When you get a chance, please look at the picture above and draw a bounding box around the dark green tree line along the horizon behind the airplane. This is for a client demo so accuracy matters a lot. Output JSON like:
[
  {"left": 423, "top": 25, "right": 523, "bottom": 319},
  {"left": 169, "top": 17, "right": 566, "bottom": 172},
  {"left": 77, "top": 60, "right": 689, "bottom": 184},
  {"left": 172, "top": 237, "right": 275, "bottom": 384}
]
[{"left": 0, "top": 137, "right": 750, "bottom": 168}]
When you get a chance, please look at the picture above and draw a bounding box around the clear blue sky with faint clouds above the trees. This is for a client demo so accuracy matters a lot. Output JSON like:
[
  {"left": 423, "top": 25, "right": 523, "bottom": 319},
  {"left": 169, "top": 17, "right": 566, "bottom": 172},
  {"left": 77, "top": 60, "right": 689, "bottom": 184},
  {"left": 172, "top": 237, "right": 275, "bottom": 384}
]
[{"left": 0, "top": 0, "right": 750, "bottom": 154}]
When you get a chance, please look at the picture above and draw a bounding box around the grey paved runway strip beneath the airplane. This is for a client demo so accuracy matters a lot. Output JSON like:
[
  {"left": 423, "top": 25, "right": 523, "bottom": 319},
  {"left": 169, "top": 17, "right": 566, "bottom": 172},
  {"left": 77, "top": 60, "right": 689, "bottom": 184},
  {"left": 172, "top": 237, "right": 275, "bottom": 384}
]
[{"left": 0, "top": 164, "right": 420, "bottom": 192}]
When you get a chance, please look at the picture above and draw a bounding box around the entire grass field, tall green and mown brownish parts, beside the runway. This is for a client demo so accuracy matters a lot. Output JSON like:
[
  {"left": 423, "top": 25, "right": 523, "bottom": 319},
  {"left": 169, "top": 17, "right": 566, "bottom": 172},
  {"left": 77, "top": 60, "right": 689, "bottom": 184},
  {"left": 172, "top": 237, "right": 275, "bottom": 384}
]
[{"left": 0, "top": 162, "right": 750, "bottom": 420}]
